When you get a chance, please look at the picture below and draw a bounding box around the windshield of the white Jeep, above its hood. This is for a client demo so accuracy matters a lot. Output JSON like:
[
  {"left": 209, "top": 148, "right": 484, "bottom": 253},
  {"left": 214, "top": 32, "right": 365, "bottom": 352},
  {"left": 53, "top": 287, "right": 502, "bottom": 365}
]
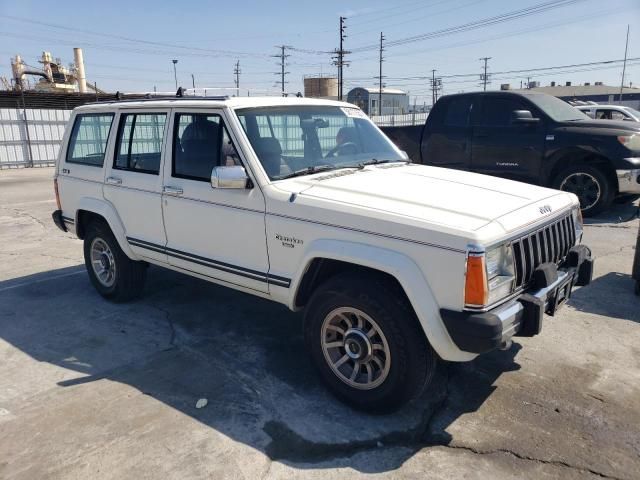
[{"left": 236, "top": 105, "right": 406, "bottom": 180}]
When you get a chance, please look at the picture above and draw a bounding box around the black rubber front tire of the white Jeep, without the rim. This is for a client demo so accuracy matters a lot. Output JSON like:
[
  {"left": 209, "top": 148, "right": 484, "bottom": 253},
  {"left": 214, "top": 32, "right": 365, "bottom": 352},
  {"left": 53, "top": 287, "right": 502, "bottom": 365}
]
[{"left": 304, "top": 273, "right": 437, "bottom": 414}]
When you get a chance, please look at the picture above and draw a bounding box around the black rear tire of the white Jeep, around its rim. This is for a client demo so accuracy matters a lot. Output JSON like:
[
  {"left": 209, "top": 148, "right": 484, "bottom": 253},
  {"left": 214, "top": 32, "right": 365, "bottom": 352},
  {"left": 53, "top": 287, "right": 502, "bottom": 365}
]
[{"left": 84, "top": 221, "right": 147, "bottom": 302}]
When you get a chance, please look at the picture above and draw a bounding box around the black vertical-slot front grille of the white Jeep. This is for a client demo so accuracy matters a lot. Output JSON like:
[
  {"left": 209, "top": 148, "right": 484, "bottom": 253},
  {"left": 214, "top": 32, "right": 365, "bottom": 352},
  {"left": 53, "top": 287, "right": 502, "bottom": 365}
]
[{"left": 511, "top": 214, "right": 576, "bottom": 289}]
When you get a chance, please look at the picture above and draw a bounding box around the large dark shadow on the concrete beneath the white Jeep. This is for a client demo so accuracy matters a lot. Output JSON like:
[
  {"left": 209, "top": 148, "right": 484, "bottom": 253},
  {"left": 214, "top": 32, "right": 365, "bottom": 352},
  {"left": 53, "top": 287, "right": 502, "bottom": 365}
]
[{"left": 0, "top": 266, "right": 520, "bottom": 473}]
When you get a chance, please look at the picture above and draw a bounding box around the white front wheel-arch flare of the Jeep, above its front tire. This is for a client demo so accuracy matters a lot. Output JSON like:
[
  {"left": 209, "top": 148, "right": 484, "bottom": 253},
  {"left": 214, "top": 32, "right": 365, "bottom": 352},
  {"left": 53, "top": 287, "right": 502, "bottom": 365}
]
[{"left": 289, "top": 239, "right": 476, "bottom": 362}]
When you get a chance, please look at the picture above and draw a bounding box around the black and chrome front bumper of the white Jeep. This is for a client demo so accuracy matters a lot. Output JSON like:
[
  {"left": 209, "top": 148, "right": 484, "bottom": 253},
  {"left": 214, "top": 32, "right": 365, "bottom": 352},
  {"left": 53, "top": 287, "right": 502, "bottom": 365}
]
[{"left": 440, "top": 245, "right": 593, "bottom": 353}]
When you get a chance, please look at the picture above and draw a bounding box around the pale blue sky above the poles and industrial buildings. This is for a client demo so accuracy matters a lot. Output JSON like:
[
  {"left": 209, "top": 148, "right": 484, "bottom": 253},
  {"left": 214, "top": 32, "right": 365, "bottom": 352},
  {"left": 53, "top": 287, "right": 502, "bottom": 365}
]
[{"left": 0, "top": 0, "right": 640, "bottom": 103}]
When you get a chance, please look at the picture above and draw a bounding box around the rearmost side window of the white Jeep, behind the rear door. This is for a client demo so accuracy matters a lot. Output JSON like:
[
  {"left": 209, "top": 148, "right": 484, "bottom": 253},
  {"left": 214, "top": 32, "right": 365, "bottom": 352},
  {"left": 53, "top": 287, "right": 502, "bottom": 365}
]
[{"left": 67, "top": 113, "right": 113, "bottom": 167}]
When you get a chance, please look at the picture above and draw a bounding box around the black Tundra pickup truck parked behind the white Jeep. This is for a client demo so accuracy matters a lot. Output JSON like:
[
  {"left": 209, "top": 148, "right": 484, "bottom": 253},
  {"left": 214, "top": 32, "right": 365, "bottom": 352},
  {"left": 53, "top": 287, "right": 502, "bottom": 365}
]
[{"left": 382, "top": 92, "right": 640, "bottom": 215}]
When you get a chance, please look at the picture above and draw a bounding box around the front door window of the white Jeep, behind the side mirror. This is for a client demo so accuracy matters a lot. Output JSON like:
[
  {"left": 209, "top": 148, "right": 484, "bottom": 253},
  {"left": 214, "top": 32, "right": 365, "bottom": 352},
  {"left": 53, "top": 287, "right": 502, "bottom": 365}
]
[{"left": 173, "top": 113, "right": 241, "bottom": 182}]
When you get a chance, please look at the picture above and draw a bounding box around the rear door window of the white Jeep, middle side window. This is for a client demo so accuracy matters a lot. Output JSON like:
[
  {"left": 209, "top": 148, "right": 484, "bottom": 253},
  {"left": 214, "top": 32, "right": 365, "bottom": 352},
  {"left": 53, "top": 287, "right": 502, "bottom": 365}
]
[{"left": 113, "top": 113, "right": 167, "bottom": 175}]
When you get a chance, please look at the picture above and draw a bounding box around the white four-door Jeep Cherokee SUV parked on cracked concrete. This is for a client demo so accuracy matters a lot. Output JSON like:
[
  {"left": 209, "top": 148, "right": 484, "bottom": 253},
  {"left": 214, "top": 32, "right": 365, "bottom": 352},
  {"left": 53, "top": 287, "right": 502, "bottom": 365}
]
[{"left": 53, "top": 91, "right": 593, "bottom": 412}]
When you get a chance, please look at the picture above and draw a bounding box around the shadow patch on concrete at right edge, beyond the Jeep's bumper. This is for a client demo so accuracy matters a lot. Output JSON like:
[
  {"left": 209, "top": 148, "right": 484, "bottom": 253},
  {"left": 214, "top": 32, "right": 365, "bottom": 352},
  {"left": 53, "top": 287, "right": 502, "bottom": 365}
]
[{"left": 567, "top": 272, "right": 640, "bottom": 323}]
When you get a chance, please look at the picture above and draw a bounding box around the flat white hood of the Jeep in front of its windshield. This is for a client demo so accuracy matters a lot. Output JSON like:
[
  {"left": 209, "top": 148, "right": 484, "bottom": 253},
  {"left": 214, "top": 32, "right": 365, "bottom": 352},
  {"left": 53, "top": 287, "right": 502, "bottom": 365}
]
[{"left": 278, "top": 164, "right": 572, "bottom": 232}]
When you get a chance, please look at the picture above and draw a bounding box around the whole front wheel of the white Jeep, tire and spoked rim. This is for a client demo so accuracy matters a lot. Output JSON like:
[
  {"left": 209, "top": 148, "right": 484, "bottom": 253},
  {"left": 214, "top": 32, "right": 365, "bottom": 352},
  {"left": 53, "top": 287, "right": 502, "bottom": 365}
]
[{"left": 305, "top": 274, "right": 436, "bottom": 413}]
